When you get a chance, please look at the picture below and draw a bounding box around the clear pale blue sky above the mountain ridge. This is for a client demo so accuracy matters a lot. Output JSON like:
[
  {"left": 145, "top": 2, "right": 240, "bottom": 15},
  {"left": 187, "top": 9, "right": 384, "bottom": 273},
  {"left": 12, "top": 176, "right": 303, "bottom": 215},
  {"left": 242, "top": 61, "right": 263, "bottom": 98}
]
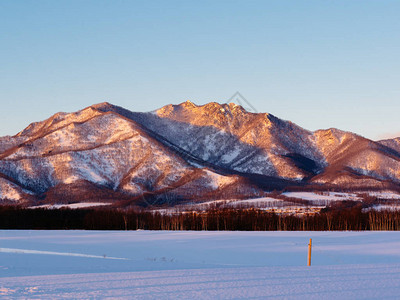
[{"left": 0, "top": 0, "right": 400, "bottom": 139}]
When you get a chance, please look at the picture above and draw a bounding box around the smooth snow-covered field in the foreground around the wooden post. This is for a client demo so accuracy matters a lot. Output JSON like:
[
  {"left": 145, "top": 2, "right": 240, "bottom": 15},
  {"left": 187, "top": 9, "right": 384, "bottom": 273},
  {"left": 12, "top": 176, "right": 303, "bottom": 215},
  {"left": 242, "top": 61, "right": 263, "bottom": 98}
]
[{"left": 0, "top": 230, "right": 400, "bottom": 299}]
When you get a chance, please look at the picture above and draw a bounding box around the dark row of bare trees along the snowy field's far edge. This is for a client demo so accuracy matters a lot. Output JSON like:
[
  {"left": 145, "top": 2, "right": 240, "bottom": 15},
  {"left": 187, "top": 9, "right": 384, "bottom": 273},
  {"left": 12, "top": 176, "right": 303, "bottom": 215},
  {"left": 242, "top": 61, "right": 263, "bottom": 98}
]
[{"left": 0, "top": 206, "right": 400, "bottom": 231}]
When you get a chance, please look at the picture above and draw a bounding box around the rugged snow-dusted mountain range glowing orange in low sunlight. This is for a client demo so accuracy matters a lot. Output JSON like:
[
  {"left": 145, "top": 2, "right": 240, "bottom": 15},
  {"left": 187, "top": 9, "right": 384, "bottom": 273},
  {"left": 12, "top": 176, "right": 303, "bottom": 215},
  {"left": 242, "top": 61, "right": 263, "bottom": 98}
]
[{"left": 0, "top": 101, "right": 400, "bottom": 205}]
